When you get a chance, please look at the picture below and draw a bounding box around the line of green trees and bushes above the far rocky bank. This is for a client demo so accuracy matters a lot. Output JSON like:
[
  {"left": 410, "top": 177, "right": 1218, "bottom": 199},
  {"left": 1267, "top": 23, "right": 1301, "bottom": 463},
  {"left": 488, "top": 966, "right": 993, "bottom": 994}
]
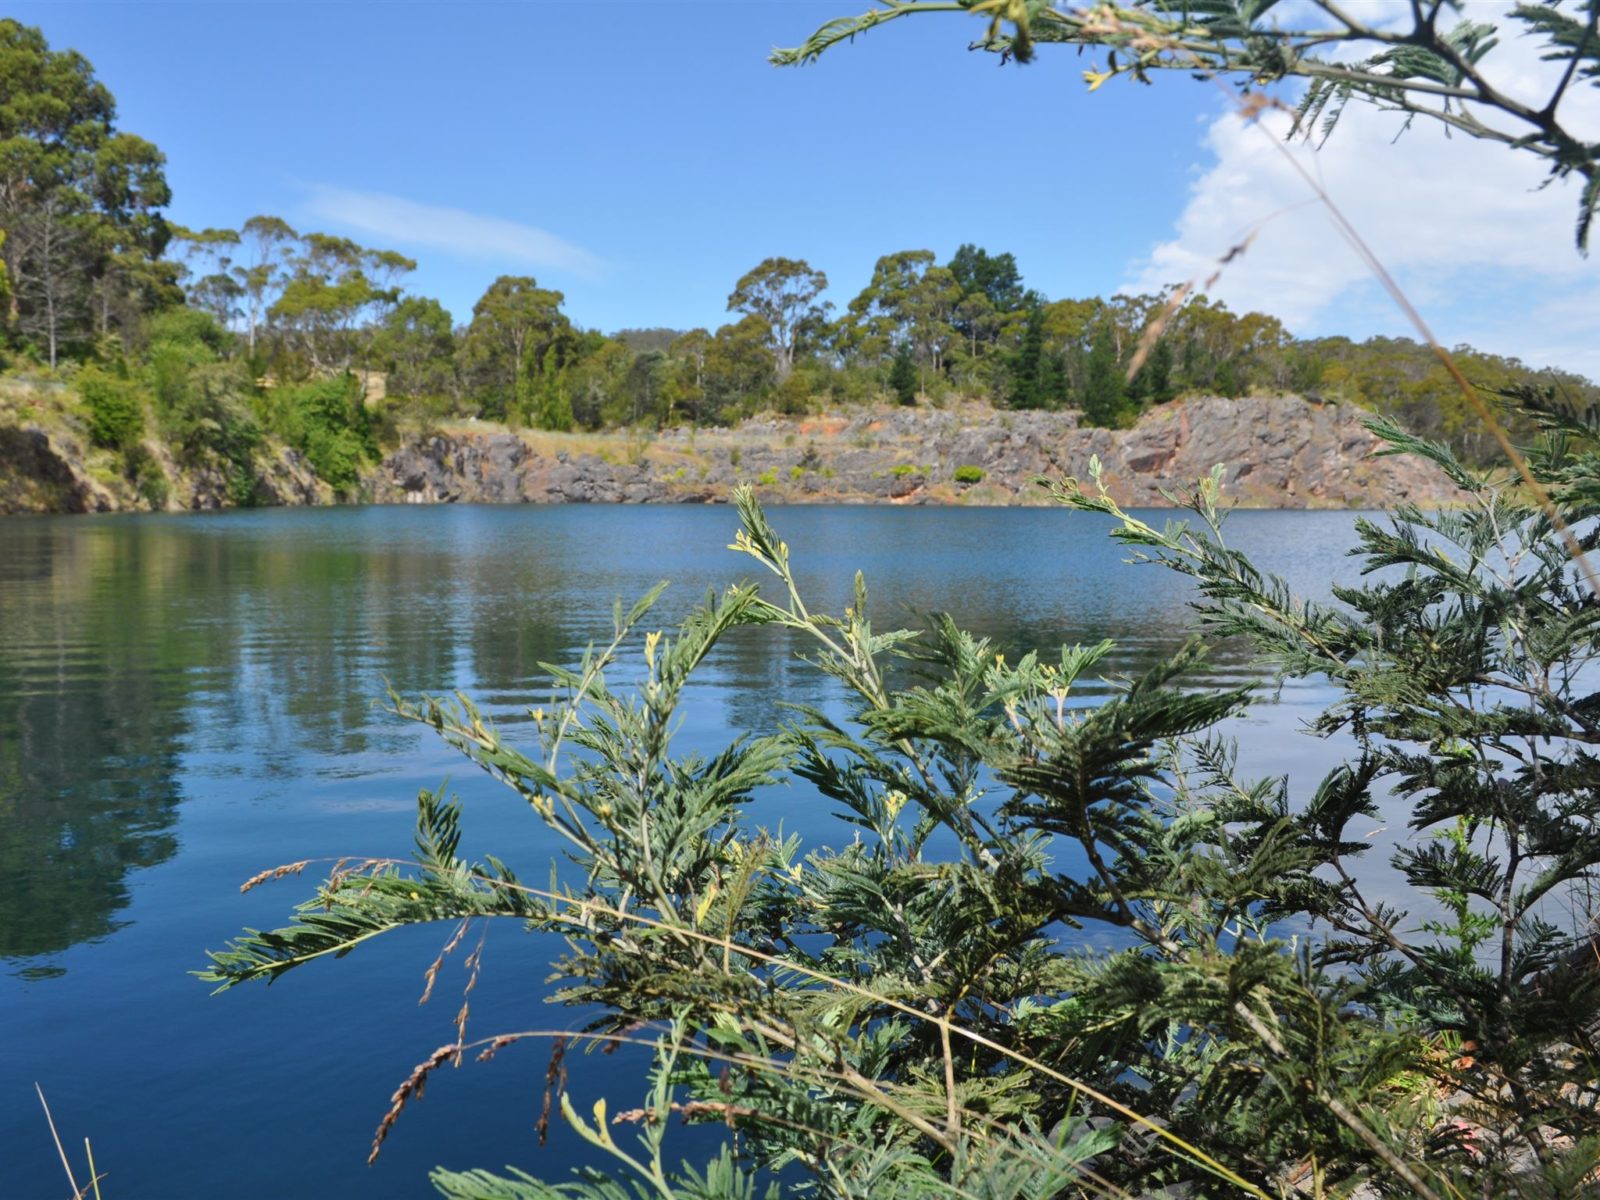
[{"left": 0, "top": 21, "right": 1594, "bottom": 499}]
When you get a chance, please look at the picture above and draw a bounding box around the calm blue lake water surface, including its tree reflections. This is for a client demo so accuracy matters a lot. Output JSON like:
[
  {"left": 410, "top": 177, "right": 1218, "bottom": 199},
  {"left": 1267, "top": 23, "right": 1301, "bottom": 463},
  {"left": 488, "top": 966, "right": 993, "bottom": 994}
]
[{"left": 0, "top": 507, "right": 1376, "bottom": 1200}]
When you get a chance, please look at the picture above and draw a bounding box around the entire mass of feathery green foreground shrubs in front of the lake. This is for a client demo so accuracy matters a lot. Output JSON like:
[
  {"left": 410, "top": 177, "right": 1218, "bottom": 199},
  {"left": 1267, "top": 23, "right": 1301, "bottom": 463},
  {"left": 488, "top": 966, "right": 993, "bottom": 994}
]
[{"left": 206, "top": 406, "right": 1600, "bottom": 1200}]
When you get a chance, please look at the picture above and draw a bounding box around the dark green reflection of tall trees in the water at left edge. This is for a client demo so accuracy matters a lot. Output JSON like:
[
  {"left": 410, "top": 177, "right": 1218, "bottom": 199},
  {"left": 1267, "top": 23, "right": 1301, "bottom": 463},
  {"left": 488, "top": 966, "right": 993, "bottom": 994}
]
[{"left": 0, "top": 525, "right": 192, "bottom": 958}]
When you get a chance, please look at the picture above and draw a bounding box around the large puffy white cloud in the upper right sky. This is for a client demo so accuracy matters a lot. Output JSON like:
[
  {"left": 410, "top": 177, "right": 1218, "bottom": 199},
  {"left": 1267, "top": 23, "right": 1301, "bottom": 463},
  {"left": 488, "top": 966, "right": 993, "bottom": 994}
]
[{"left": 1125, "top": 8, "right": 1600, "bottom": 379}]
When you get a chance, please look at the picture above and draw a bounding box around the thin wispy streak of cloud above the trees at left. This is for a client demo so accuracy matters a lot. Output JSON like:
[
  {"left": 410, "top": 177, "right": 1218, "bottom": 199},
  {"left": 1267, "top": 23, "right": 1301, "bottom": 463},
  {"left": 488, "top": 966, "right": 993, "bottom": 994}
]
[{"left": 307, "top": 184, "right": 605, "bottom": 278}]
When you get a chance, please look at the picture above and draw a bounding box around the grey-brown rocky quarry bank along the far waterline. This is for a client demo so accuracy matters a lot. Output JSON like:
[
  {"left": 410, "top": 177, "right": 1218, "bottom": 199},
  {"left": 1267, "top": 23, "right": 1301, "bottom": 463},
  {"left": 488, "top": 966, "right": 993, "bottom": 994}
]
[{"left": 0, "top": 395, "right": 1456, "bottom": 514}]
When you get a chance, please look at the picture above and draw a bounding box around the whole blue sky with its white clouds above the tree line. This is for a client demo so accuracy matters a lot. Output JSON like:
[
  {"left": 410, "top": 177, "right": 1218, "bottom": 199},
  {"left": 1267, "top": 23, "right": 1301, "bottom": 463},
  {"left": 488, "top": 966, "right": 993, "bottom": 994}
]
[{"left": 6, "top": 0, "right": 1600, "bottom": 379}]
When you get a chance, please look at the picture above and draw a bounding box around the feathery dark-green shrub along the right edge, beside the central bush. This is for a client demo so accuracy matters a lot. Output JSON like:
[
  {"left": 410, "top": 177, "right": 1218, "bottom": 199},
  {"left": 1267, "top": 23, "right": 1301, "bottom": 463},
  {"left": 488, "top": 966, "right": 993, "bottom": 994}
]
[{"left": 1036, "top": 410, "right": 1600, "bottom": 1194}]
